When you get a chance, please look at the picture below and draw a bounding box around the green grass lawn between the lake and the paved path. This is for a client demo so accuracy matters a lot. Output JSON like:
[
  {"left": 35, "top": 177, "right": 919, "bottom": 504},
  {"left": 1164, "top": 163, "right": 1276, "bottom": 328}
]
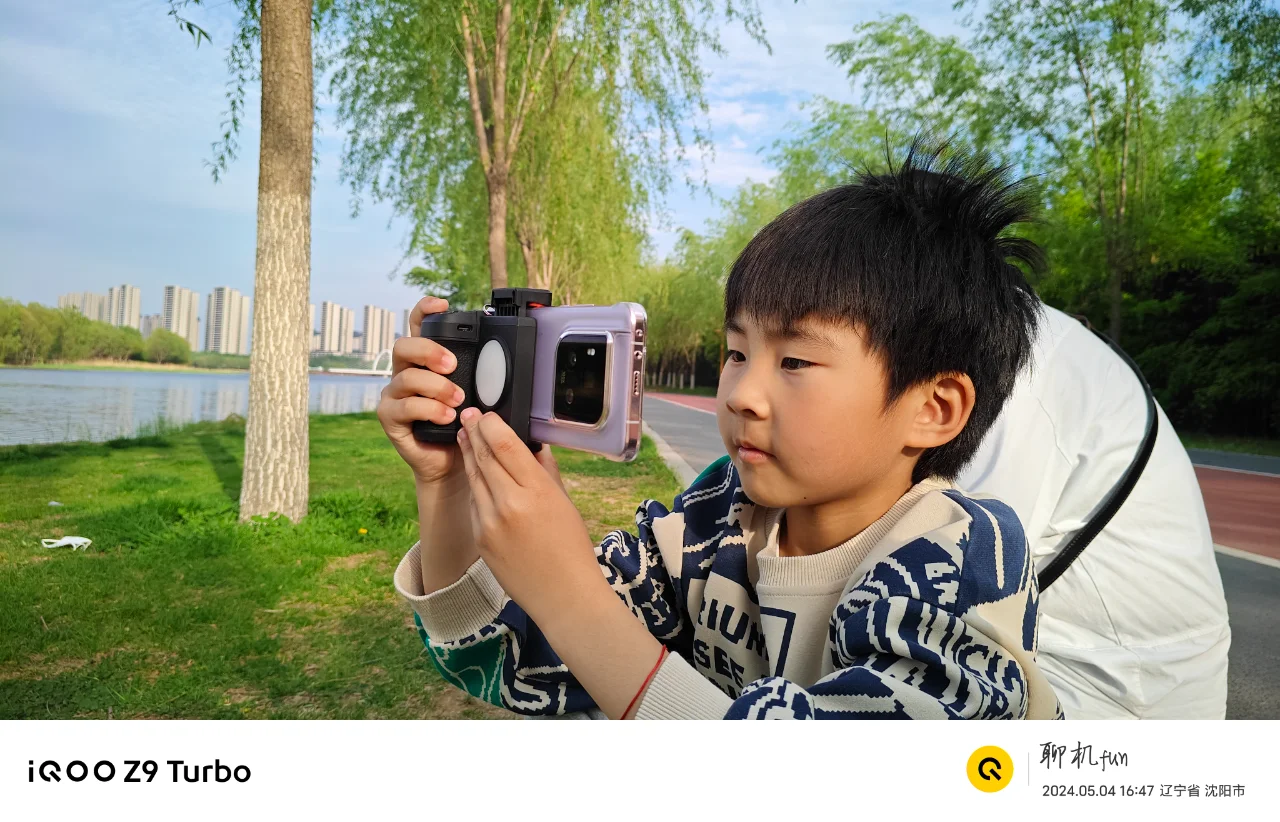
[{"left": 0, "top": 414, "right": 678, "bottom": 718}]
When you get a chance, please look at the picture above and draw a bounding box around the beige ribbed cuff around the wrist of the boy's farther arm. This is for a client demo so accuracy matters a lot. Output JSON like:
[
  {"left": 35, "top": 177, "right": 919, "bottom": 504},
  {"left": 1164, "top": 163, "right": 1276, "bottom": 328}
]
[{"left": 396, "top": 543, "right": 507, "bottom": 643}]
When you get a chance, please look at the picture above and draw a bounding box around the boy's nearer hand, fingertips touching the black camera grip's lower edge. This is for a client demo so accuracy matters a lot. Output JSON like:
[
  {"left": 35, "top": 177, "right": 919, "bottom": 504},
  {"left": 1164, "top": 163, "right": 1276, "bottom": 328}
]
[{"left": 458, "top": 408, "right": 599, "bottom": 619}]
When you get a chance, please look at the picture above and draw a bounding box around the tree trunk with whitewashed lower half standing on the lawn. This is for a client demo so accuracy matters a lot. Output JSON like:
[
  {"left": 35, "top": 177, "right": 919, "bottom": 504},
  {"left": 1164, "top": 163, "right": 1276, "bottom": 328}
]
[{"left": 239, "top": 0, "right": 315, "bottom": 521}]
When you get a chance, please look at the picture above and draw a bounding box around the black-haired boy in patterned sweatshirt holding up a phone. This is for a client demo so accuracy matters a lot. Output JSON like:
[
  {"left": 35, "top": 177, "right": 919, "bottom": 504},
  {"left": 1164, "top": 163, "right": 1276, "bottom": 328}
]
[{"left": 379, "top": 146, "right": 1061, "bottom": 718}]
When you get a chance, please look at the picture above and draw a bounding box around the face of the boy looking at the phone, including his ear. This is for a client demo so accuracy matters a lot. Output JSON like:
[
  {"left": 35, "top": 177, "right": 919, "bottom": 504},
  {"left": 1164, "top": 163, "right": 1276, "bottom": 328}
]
[{"left": 716, "top": 316, "right": 915, "bottom": 508}]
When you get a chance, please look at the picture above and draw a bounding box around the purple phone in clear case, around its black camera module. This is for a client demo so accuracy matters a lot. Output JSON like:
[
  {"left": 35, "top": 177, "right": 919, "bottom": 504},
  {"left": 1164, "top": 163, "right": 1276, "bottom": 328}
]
[{"left": 529, "top": 302, "right": 648, "bottom": 461}]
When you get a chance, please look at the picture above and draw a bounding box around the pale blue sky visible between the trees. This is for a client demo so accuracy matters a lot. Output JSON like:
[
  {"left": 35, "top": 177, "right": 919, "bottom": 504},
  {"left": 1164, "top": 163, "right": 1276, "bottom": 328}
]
[{"left": 0, "top": 0, "right": 959, "bottom": 326}]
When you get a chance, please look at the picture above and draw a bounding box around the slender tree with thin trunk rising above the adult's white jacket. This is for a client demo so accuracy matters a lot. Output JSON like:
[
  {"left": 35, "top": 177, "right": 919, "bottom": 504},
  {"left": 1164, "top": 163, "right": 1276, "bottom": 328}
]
[{"left": 828, "top": 0, "right": 1176, "bottom": 339}]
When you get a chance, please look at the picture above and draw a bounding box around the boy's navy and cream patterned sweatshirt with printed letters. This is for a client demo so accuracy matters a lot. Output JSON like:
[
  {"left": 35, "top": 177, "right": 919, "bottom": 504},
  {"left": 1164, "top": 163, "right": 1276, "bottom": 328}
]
[{"left": 396, "top": 457, "right": 1062, "bottom": 720}]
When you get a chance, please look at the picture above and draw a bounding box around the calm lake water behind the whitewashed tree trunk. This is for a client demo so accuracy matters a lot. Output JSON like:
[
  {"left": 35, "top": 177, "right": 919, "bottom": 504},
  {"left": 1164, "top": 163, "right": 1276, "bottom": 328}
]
[{"left": 0, "top": 369, "right": 388, "bottom": 446}]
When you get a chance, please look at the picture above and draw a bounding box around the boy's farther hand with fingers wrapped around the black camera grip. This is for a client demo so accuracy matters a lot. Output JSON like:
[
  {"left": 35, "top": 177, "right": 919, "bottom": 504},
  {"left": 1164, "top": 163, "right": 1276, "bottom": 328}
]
[{"left": 378, "top": 297, "right": 463, "bottom": 484}]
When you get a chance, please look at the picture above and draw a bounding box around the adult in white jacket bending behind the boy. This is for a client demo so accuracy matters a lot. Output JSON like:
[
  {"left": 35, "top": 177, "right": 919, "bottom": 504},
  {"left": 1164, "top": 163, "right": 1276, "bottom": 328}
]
[{"left": 956, "top": 306, "right": 1231, "bottom": 718}]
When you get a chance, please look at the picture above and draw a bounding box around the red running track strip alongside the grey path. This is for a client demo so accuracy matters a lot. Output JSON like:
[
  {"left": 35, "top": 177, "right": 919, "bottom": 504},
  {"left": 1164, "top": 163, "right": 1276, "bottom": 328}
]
[{"left": 649, "top": 392, "right": 1280, "bottom": 560}]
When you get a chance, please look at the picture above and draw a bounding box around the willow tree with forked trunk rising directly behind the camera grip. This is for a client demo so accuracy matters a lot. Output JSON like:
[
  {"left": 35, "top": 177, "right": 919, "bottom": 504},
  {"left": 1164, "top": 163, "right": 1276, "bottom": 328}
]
[{"left": 333, "top": 0, "right": 763, "bottom": 288}]
